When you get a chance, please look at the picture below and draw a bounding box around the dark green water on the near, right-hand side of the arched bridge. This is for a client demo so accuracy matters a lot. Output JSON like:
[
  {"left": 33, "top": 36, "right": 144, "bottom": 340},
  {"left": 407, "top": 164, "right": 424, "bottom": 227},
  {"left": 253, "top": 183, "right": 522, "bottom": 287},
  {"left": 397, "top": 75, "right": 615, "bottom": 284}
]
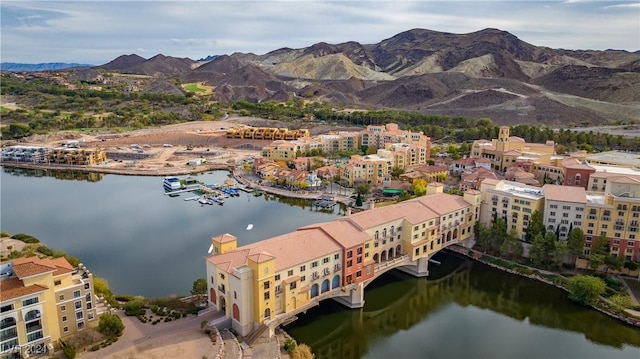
[{"left": 286, "top": 253, "right": 640, "bottom": 358}]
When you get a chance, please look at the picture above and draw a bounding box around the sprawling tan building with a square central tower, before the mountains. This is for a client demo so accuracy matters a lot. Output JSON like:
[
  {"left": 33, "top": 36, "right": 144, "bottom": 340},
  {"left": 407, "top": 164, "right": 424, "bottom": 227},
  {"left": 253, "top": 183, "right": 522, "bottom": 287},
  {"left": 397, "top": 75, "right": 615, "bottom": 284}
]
[{"left": 471, "top": 126, "right": 555, "bottom": 172}]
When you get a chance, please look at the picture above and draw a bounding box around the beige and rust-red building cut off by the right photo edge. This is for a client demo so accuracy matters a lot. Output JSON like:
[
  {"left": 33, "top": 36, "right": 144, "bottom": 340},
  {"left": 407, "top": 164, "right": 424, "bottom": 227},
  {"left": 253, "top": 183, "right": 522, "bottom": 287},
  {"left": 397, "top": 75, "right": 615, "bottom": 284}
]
[{"left": 583, "top": 172, "right": 640, "bottom": 261}]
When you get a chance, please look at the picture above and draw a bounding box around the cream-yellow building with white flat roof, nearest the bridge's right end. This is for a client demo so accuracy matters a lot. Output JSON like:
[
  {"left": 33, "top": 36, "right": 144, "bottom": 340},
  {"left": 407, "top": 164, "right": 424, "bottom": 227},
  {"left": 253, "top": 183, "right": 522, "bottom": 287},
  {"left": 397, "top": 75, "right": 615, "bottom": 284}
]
[{"left": 480, "top": 179, "right": 544, "bottom": 239}]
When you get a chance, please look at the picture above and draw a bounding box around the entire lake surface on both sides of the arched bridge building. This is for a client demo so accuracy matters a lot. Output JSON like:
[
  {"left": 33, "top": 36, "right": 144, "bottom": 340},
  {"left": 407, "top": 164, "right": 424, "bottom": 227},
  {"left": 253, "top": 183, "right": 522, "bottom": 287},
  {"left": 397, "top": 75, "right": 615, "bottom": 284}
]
[{"left": 0, "top": 168, "right": 640, "bottom": 359}]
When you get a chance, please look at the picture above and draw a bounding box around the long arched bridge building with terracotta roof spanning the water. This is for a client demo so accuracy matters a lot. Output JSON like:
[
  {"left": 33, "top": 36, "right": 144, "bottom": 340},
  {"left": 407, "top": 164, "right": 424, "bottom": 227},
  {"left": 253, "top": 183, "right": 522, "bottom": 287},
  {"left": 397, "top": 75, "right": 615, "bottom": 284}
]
[{"left": 206, "top": 184, "right": 480, "bottom": 336}]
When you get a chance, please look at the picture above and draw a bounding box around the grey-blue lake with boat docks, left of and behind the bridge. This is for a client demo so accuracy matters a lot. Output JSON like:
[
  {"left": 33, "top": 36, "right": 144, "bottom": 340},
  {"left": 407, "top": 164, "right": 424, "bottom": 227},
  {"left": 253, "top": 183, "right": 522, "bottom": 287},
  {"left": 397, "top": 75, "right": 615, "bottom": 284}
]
[{"left": 0, "top": 168, "right": 340, "bottom": 297}]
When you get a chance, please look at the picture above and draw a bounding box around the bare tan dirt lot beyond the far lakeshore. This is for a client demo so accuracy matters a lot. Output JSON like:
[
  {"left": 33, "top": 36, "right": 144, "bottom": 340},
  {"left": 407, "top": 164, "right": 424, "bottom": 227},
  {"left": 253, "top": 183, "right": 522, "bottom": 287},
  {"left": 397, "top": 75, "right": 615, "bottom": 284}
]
[{"left": 3, "top": 117, "right": 356, "bottom": 175}]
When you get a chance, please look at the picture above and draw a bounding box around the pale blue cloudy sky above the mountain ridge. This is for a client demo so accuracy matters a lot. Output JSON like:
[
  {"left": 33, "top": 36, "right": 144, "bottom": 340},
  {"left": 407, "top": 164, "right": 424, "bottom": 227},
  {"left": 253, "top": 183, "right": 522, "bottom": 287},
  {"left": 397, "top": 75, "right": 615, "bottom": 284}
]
[{"left": 0, "top": 0, "right": 640, "bottom": 65}]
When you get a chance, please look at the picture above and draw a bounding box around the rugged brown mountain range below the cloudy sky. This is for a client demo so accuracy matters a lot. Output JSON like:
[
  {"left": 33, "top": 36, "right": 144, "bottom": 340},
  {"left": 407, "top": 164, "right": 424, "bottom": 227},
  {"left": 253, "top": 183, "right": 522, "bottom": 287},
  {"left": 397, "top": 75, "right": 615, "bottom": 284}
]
[{"left": 11, "top": 29, "right": 640, "bottom": 125}]
